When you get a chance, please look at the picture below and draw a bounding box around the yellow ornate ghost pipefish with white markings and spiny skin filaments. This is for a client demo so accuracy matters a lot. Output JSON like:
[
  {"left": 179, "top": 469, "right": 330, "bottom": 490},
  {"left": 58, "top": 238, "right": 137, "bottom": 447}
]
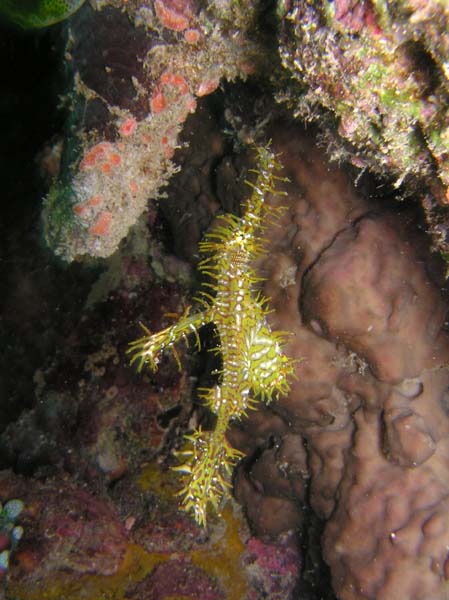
[{"left": 130, "top": 147, "right": 294, "bottom": 525}]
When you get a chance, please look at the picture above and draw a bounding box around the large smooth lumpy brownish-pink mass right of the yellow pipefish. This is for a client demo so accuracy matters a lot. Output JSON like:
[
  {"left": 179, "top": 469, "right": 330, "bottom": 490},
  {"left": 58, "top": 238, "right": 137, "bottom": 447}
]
[{"left": 229, "top": 124, "right": 449, "bottom": 600}]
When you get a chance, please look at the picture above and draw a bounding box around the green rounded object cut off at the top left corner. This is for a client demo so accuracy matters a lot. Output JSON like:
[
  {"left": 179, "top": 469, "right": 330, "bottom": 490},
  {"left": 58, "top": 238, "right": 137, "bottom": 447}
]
[{"left": 0, "top": 0, "right": 85, "bottom": 29}]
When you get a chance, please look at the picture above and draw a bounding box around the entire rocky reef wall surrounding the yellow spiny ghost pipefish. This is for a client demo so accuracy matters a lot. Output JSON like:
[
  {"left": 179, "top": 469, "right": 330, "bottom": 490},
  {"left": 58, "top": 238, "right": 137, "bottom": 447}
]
[{"left": 0, "top": 0, "right": 449, "bottom": 600}]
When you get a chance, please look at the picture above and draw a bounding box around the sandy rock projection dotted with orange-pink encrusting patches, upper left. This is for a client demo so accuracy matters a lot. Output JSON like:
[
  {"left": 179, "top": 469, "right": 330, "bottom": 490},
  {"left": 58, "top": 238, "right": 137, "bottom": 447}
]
[{"left": 43, "top": 0, "right": 264, "bottom": 261}]
